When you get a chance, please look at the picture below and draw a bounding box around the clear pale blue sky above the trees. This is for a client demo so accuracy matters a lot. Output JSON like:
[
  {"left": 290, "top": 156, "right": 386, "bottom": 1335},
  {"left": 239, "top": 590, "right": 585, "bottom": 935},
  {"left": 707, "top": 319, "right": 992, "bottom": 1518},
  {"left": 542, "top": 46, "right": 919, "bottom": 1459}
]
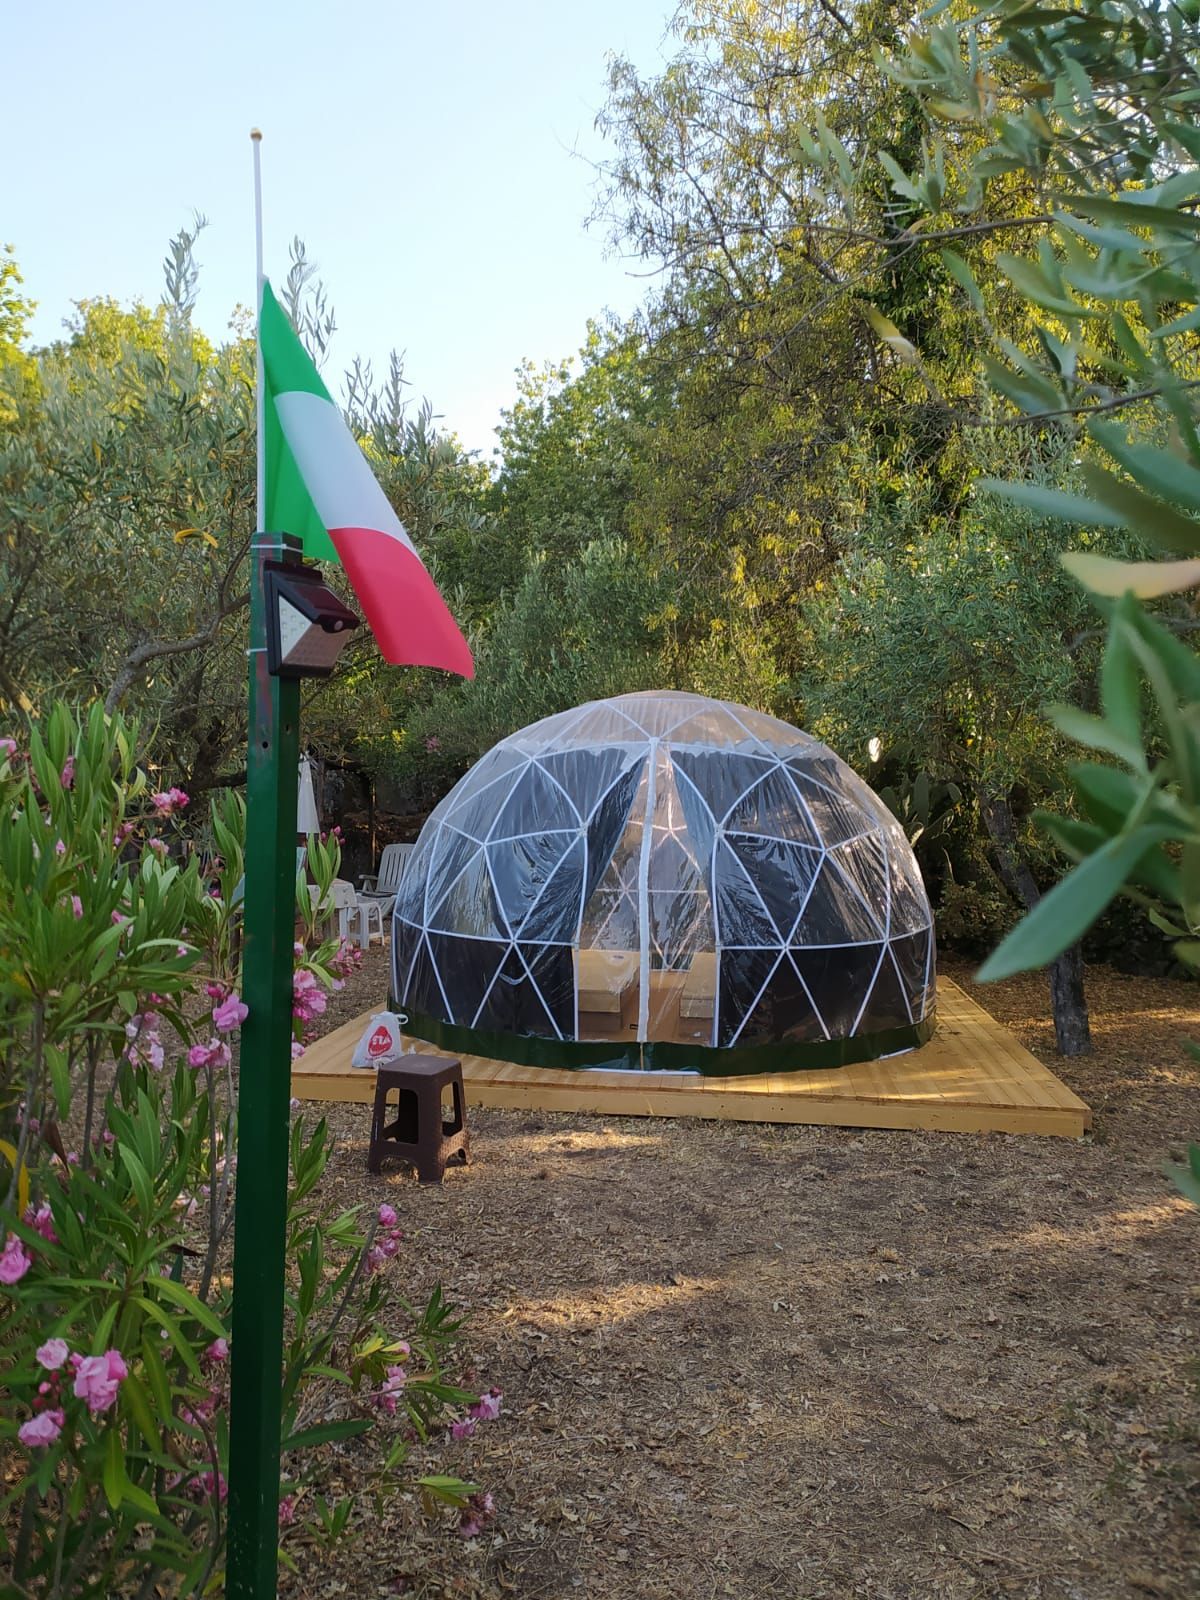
[{"left": 0, "top": 0, "right": 674, "bottom": 459}]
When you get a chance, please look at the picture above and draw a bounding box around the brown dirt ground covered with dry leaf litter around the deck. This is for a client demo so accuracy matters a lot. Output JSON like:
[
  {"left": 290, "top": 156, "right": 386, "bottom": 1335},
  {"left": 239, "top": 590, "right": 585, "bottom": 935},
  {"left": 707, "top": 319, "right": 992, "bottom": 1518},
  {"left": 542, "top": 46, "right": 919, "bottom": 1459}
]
[{"left": 300, "top": 952, "right": 1200, "bottom": 1600}]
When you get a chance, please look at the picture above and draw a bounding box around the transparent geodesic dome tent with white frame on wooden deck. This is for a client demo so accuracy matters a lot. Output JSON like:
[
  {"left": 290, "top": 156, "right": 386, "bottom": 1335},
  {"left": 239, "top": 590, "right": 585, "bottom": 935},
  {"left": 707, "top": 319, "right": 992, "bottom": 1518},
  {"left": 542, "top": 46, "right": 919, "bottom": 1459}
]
[{"left": 392, "top": 691, "right": 934, "bottom": 1075}]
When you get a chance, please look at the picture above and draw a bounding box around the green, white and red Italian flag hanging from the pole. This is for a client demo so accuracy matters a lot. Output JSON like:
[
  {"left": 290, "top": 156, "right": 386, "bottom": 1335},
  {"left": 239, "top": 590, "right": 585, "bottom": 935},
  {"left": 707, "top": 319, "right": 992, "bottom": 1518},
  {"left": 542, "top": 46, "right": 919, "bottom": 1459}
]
[{"left": 259, "top": 283, "right": 475, "bottom": 678}]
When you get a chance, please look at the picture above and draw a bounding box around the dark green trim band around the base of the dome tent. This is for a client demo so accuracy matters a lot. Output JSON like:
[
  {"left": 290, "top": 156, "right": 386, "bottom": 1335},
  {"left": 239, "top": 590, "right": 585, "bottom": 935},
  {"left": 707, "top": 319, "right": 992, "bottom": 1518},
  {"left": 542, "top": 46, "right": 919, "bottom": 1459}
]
[{"left": 389, "top": 1000, "right": 938, "bottom": 1078}]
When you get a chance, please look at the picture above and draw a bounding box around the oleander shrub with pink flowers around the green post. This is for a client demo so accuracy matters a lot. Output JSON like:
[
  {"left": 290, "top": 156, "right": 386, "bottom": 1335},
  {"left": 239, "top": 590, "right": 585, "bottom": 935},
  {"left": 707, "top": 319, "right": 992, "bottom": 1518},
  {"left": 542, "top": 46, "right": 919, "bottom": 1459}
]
[{"left": 0, "top": 707, "right": 489, "bottom": 1600}]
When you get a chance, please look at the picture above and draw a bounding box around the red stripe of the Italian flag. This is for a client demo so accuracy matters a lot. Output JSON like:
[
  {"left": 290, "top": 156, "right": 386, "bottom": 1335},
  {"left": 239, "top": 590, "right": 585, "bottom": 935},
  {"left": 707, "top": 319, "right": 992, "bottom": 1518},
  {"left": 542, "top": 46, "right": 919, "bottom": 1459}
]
[{"left": 330, "top": 528, "right": 475, "bottom": 678}]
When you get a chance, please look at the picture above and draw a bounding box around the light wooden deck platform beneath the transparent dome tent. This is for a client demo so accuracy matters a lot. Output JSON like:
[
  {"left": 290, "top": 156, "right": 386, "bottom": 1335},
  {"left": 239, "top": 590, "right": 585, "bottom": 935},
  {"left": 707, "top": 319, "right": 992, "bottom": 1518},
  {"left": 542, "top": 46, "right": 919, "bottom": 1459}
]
[{"left": 291, "top": 978, "right": 1091, "bottom": 1139}]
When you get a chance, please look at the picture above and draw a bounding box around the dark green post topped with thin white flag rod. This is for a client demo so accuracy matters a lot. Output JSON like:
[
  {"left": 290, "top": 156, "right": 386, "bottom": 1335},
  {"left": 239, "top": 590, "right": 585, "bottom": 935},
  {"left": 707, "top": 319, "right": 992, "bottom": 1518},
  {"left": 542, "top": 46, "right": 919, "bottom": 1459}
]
[{"left": 226, "top": 128, "right": 299, "bottom": 1600}]
